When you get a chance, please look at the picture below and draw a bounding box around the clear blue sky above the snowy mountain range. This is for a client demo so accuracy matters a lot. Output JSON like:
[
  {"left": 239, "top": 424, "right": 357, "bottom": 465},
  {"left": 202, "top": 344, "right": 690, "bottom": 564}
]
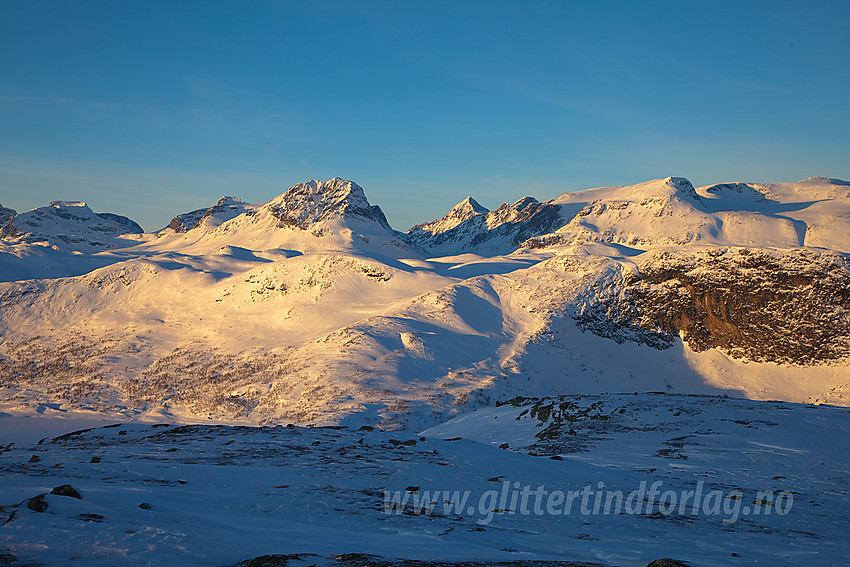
[{"left": 0, "top": 0, "right": 850, "bottom": 230}]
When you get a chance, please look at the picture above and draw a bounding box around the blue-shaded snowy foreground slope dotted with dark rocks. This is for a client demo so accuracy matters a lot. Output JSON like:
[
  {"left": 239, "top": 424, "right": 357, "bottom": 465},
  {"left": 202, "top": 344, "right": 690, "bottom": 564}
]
[{"left": 0, "top": 394, "right": 850, "bottom": 566}]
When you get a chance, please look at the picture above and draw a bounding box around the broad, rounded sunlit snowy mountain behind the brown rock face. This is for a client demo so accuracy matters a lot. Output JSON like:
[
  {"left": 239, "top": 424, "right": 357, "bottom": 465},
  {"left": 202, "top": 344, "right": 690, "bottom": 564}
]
[{"left": 525, "top": 177, "right": 850, "bottom": 252}]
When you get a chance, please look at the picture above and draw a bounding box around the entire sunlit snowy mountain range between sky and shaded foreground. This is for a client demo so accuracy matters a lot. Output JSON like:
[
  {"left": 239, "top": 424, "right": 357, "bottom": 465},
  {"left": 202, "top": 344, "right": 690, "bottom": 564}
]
[{"left": 0, "top": 177, "right": 850, "bottom": 429}]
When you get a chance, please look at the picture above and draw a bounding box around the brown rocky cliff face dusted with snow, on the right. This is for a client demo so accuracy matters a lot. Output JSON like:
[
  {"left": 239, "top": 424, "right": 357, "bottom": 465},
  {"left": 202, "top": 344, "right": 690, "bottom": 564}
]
[{"left": 576, "top": 248, "right": 850, "bottom": 364}]
